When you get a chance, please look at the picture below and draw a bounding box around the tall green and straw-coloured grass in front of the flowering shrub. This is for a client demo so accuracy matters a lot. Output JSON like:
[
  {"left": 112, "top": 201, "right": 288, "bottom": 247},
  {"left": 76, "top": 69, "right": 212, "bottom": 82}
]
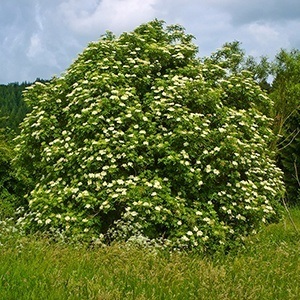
[{"left": 0, "top": 209, "right": 300, "bottom": 300}]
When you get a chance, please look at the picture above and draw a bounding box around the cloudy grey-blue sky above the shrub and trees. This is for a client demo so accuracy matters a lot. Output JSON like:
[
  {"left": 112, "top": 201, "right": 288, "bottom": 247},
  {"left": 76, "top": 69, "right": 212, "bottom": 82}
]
[{"left": 0, "top": 0, "right": 300, "bottom": 84}]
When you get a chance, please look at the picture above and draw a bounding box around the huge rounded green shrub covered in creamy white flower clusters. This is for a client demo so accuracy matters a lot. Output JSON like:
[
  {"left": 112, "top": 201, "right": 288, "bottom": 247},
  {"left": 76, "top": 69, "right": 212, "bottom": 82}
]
[{"left": 16, "top": 20, "right": 283, "bottom": 250}]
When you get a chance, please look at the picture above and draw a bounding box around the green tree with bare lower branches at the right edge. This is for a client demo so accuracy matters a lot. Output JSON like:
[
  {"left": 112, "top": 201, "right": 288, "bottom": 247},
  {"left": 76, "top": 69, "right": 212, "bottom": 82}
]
[{"left": 270, "top": 50, "right": 300, "bottom": 204}]
